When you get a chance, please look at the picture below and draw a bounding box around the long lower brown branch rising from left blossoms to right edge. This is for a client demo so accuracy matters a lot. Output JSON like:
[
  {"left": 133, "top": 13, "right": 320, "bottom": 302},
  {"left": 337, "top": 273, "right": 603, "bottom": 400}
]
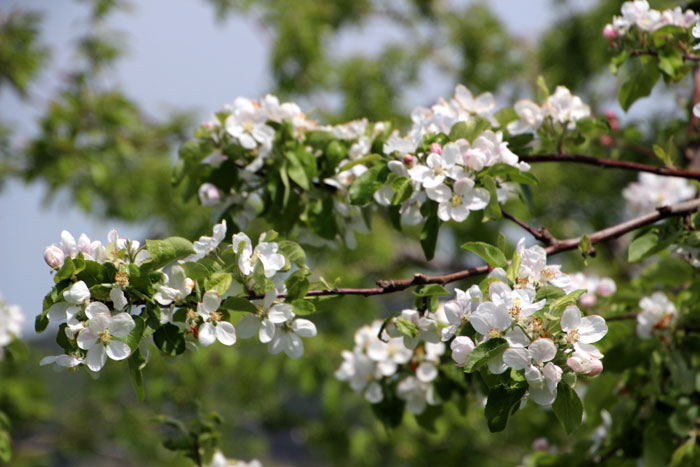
[{"left": 248, "top": 198, "right": 700, "bottom": 300}]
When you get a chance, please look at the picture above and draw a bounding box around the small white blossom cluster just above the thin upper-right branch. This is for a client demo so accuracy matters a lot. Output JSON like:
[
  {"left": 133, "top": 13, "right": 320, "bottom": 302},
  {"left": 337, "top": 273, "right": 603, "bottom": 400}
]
[{"left": 507, "top": 86, "right": 591, "bottom": 135}]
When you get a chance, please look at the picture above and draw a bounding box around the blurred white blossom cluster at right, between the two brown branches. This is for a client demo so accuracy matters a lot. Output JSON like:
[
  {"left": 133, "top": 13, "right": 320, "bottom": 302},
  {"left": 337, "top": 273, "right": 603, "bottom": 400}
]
[{"left": 622, "top": 172, "right": 697, "bottom": 213}]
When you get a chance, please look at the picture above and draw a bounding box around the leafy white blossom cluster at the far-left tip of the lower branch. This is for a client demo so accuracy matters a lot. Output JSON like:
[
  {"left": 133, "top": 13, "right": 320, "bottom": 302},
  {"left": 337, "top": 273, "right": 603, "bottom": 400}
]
[{"left": 37, "top": 221, "right": 316, "bottom": 372}]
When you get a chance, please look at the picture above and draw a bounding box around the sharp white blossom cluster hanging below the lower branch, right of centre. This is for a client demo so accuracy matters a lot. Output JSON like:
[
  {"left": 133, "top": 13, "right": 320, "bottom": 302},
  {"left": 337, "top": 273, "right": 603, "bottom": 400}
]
[{"left": 443, "top": 240, "right": 607, "bottom": 406}]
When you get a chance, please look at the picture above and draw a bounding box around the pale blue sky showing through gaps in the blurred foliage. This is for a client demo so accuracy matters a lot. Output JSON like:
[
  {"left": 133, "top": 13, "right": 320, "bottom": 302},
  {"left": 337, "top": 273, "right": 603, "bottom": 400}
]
[{"left": 0, "top": 0, "right": 590, "bottom": 337}]
